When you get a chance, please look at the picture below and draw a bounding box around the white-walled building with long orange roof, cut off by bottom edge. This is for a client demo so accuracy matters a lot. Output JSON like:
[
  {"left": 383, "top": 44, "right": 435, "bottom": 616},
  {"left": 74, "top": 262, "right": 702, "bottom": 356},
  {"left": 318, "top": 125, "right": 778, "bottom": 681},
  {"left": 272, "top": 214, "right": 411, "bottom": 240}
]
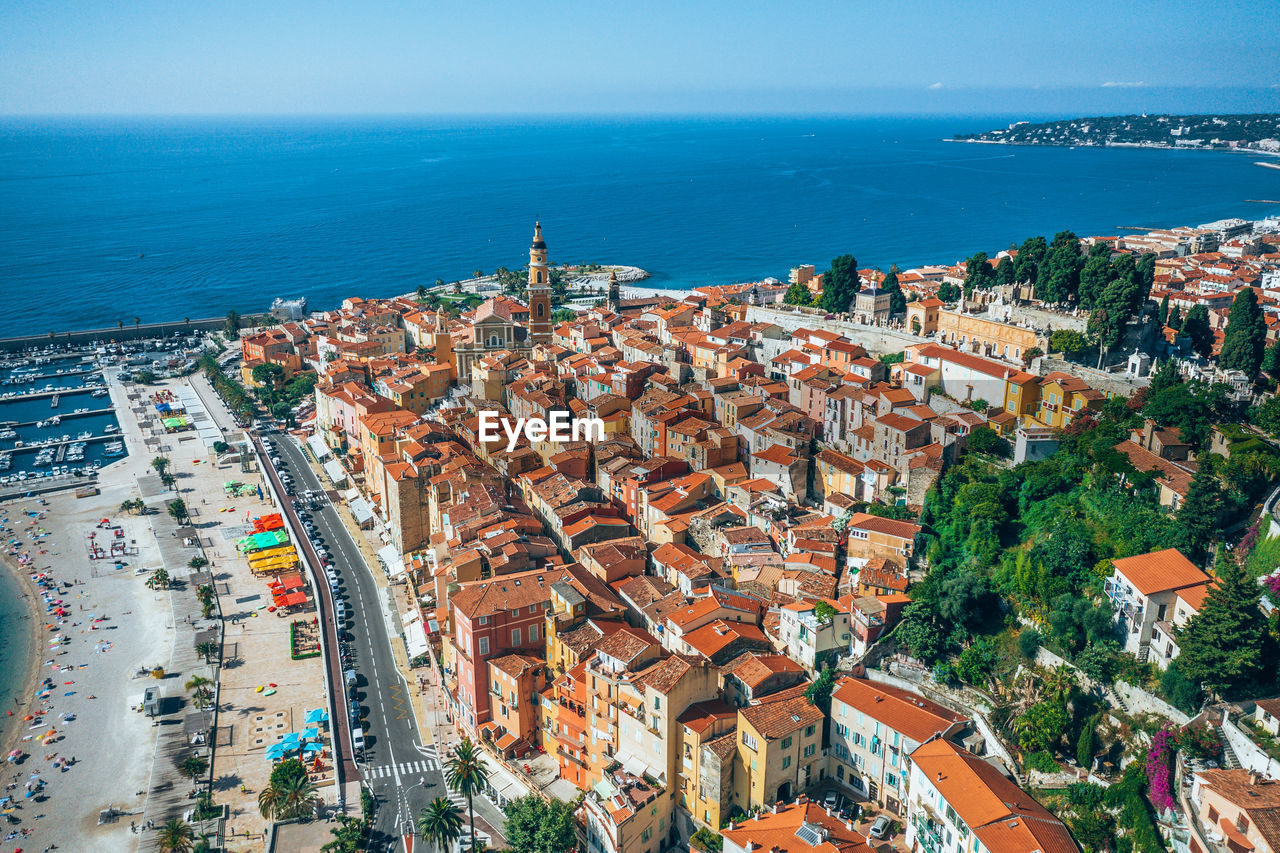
[{"left": 906, "top": 738, "right": 1079, "bottom": 853}]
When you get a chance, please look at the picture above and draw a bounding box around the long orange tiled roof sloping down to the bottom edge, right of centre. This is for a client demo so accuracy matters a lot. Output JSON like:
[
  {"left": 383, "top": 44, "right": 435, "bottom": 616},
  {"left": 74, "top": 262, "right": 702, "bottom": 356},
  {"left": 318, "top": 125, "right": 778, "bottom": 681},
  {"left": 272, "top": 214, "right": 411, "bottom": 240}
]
[{"left": 911, "top": 738, "right": 1079, "bottom": 853}]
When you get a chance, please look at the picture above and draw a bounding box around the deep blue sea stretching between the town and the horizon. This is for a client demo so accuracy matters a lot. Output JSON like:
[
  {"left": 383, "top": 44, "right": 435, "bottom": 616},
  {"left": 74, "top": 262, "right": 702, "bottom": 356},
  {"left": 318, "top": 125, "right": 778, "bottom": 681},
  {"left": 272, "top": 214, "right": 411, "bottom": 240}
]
[{"left": 0, "top": 117, "right": 1280, "bottom": 336}]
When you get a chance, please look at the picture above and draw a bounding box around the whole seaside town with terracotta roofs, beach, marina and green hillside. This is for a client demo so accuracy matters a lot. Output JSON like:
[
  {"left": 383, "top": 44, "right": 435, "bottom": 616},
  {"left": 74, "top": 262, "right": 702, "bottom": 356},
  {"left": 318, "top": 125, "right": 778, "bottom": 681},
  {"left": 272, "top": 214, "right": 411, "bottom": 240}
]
[{"left": 0, "top": 212, "right": 1280, "bottom": 853}]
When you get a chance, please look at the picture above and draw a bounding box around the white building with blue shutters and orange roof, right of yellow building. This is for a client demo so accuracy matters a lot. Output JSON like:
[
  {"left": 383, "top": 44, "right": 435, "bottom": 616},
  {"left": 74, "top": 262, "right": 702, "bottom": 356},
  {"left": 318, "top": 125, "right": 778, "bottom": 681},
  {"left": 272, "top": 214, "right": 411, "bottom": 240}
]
[{"left": 829, "top": 678, "right": 968, "bottom": 817}]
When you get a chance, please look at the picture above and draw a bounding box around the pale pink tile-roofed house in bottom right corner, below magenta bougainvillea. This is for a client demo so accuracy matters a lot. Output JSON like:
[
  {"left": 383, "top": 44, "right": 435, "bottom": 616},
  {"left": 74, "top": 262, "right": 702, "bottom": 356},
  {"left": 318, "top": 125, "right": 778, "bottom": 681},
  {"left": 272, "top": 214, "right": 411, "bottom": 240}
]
[{"left": 1192, "top": 770, "right": 1280, "bottom": 853}]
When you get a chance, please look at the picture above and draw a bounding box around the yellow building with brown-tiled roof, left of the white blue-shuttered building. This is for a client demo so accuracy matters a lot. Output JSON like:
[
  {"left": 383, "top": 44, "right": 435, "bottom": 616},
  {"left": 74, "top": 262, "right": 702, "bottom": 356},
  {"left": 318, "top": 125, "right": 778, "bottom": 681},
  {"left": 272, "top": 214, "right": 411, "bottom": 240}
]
[{"left": 733, "top": 686, "right": 827, "bottom": 811}]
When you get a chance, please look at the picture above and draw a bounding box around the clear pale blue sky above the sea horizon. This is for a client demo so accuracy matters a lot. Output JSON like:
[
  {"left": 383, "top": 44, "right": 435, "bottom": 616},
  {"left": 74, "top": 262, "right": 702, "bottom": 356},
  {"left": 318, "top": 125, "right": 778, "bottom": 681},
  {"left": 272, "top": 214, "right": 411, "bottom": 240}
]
[{"left": 0, "top": 0, "right": 1280, "bottom": 115}]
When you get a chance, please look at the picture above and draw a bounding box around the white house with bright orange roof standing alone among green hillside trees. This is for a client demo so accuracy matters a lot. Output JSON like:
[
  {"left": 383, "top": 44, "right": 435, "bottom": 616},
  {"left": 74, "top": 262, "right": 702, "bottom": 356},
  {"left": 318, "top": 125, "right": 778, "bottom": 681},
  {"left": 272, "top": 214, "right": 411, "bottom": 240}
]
[{"left": 1105, "top": 548, "right": 1212, "bottom": 669}]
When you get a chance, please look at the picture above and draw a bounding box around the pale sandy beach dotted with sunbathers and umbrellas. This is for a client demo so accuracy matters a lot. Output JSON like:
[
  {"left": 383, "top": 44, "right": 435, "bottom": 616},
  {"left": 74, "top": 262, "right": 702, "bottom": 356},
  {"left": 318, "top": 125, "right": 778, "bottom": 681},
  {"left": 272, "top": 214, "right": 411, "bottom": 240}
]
[{"left": 0, "top": 373, "right": 183, "bottom": 852}]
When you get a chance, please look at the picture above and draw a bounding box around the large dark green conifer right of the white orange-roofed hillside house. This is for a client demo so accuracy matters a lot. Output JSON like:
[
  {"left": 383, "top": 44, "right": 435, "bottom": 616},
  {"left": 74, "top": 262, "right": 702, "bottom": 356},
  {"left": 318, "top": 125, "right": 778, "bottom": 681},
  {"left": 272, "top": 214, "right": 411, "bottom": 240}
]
[{"left": 1178, "top": 558, "right": 1275, "bottom": 698}]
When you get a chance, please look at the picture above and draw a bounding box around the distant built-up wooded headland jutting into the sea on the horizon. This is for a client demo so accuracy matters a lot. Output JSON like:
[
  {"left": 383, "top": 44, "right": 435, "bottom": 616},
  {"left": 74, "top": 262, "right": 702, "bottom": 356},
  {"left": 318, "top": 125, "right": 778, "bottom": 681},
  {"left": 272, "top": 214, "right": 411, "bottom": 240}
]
[{"left": 947, "top": 113, "right": 1280, "bottom": 154}]
